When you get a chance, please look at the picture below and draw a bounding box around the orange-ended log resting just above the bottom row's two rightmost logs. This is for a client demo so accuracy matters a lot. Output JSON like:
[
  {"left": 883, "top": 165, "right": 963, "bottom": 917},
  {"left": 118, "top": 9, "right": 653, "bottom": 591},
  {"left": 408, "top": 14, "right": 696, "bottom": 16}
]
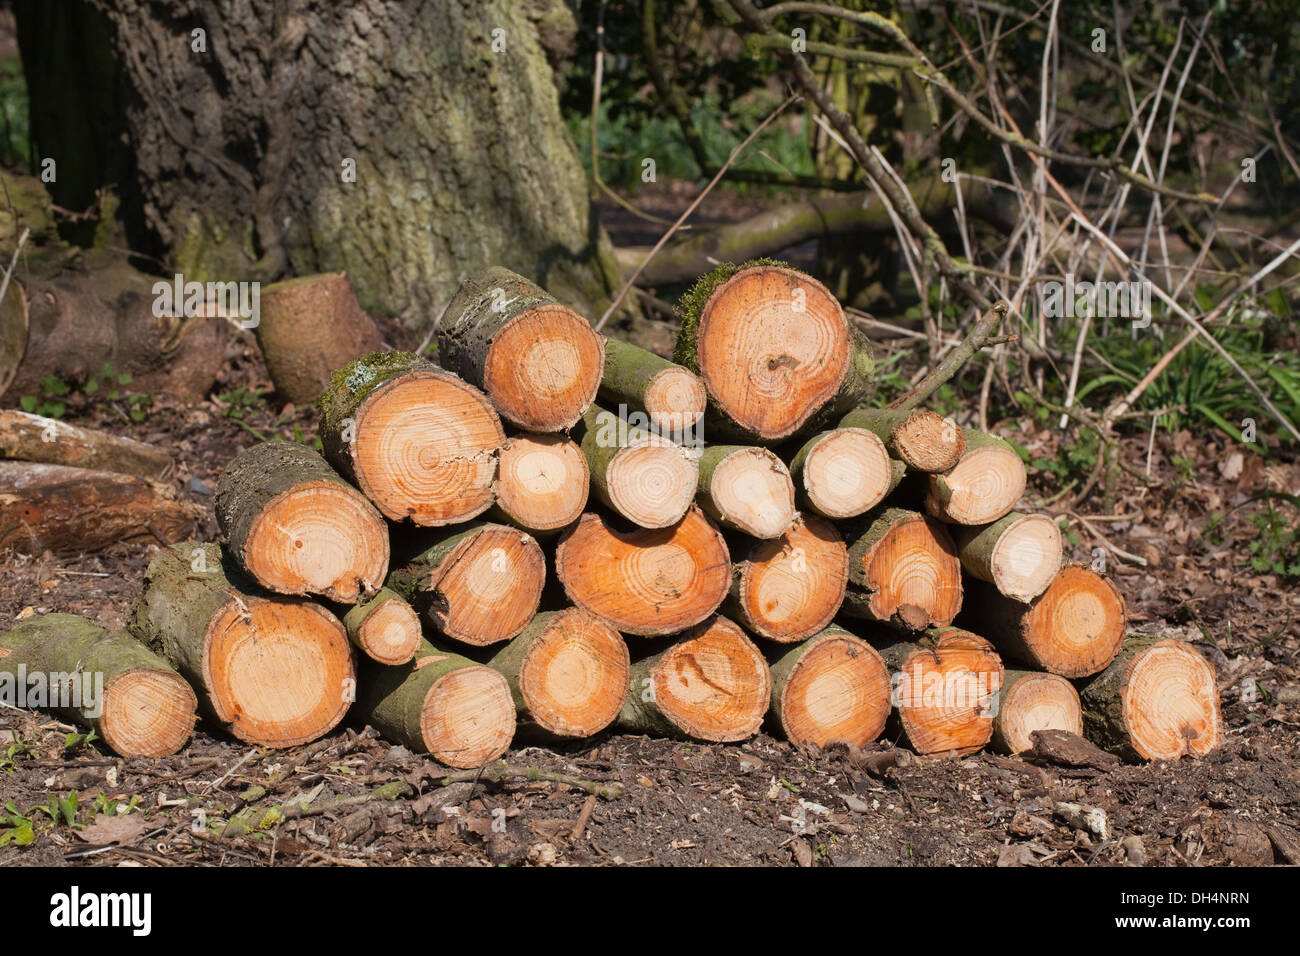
[{"left": 963, "top": 564, "right": 1127, "bottom": 678}]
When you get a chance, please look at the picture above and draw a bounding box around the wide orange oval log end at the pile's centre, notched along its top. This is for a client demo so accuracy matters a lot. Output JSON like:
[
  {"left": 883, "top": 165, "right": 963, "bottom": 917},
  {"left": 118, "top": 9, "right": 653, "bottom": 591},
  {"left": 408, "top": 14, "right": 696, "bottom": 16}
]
[{"left": 555, "top": 507, "right": 731, "bottom": 636}]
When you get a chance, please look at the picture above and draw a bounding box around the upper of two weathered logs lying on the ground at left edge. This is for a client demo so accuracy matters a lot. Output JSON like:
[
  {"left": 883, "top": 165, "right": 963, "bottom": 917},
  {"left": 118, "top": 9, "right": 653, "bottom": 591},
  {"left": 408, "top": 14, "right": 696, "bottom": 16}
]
[{"left": 0, "top": 410, "right": 173, "bottom": 481}]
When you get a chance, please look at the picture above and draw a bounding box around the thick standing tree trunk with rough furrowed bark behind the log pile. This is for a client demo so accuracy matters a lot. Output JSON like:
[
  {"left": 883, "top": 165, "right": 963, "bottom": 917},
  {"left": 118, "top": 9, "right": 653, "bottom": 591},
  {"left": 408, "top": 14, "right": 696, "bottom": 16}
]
[{"left": 73, "top": 0, "right": 619, "bottom": 328}]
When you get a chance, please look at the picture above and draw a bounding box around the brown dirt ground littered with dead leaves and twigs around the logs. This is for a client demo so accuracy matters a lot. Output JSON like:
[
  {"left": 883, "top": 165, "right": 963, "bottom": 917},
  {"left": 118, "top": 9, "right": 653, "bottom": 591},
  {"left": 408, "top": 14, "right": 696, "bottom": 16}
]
[{"left": 0, "top": 188, "right": 1300, "bottom": 866}]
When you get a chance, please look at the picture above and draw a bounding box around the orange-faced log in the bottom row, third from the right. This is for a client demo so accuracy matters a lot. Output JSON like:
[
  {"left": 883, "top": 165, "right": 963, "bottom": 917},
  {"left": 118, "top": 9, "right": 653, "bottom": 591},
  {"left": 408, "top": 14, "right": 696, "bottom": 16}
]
[{"left": 876, "top": 627, "right": 1002, "bottom": 754}]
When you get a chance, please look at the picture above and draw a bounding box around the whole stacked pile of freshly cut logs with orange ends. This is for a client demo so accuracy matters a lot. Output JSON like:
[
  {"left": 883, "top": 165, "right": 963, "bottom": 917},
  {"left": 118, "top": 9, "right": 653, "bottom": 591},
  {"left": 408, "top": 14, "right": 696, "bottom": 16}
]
[{"left": 0, "top": 261, "right": 1222, "bottom": 767}]
